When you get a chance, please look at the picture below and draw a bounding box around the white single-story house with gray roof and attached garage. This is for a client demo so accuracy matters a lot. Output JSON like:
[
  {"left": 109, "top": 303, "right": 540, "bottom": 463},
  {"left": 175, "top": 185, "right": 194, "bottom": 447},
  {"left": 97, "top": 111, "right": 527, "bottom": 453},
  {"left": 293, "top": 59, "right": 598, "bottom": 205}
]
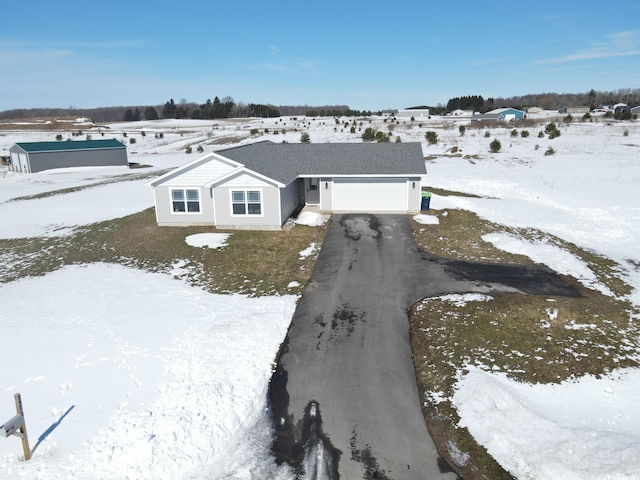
[{"left": 147, "top": 141, "right": 426, "bottom": 230}]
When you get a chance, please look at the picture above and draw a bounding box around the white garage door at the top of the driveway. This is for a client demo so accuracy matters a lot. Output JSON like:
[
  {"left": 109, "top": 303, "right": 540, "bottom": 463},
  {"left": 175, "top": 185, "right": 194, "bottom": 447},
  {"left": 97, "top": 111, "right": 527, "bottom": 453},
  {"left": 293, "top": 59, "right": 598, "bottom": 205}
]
[{"left": 333, "top": 178, "right": 408, "bottom": 212}]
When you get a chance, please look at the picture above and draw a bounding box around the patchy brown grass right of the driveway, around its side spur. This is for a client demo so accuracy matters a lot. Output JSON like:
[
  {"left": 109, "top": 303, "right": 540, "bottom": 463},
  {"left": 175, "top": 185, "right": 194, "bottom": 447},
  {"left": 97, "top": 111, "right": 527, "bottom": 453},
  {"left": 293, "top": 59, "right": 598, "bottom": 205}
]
[{"left": 410, "top": 193, "right": 640, "bottom": 480}]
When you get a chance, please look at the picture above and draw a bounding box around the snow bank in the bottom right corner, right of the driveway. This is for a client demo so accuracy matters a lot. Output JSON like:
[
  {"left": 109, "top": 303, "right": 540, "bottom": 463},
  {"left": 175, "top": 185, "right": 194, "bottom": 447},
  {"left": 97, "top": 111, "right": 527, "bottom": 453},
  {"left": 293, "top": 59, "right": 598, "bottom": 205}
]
[{"left": 452, "top": 367, "right": 640, "bottom": 480}]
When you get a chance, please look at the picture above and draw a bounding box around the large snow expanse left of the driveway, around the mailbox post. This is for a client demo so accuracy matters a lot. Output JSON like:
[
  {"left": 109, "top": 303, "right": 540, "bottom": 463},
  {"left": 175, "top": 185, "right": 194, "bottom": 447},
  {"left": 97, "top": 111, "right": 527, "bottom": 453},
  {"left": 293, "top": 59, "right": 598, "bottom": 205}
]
[{"left": 0, "top": 264, "right": 296, "bottom": 479}]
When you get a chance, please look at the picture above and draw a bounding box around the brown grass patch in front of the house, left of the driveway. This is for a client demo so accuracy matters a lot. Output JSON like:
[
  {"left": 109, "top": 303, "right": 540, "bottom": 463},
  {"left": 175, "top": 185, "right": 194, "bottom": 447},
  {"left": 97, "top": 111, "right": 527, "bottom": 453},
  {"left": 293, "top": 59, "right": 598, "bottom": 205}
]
[{"left": 0, "top": 209, "right": 327, "bottom": 296}]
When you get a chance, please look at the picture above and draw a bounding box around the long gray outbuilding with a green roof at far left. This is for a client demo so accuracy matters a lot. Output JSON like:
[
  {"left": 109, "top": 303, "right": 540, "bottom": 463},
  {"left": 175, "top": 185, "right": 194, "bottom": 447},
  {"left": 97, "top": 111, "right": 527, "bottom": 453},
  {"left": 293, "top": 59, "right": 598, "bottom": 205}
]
[{"left": 9, "top": 139, "right": 129, "bottom": 173}]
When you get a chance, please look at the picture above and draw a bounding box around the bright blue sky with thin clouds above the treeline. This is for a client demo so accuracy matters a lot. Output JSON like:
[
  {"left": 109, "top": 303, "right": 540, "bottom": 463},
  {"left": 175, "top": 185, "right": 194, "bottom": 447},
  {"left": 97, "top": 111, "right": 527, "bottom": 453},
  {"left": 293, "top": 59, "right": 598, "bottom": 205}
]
[{"left": 0, "top": 0, "right": 640, "bottom": 111}]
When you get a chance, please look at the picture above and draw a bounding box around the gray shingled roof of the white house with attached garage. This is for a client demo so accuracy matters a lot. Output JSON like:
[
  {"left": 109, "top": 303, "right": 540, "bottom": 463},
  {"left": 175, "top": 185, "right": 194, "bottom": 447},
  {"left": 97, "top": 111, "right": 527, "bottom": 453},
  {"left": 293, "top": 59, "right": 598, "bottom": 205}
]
[{"left": 216, "top": 142, "right": 426, "bottom": 185}]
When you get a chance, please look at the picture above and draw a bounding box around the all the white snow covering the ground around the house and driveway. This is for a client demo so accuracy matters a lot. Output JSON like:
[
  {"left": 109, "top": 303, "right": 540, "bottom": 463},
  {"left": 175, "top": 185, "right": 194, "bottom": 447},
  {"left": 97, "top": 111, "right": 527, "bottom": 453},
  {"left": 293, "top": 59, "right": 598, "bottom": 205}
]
[{"left": 0, "top": 113, "right": 640, "bottom": 480}]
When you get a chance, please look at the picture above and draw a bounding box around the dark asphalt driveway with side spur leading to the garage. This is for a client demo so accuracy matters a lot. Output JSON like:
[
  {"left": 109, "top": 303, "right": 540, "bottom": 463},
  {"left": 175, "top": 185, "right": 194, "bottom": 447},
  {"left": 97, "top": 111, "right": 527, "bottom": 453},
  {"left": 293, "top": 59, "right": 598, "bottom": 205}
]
[{"left": 269, "top": 215, "right": 576, "bottom": 479}]
